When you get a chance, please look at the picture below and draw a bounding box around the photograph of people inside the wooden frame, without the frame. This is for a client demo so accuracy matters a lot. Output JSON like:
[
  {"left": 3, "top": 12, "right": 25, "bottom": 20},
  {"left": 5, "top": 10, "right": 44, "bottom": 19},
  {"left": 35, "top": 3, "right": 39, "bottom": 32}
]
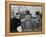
[{"left": 10, "top": 4, "right": 42, "bottom": 32}]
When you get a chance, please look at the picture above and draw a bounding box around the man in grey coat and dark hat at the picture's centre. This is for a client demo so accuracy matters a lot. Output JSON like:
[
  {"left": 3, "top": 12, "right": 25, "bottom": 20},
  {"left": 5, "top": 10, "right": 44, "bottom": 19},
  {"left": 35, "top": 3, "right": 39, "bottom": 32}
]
[{"left": 21, "top": 10, "right": 32, "bottom": 32}]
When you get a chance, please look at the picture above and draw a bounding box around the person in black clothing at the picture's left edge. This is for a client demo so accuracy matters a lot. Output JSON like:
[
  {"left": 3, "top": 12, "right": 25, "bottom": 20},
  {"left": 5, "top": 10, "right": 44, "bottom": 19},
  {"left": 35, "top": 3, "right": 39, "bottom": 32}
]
[{"left": 10, "top": 10, "right": 21, "bottom": 32}]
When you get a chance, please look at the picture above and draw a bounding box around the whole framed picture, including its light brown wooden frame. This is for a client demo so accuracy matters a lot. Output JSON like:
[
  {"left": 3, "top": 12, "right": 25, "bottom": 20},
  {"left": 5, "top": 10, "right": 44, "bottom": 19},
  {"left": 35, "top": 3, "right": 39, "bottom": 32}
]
[{"left": 5, "top": 1, "right": 45, "bottom": 36}]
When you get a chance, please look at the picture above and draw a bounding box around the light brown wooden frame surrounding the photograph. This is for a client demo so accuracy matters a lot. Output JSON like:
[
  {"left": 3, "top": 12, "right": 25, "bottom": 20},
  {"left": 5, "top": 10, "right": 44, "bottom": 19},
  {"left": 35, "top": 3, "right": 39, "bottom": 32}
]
[{"left": 5, "top": 1, "right": 45, "bottom": 36}]
